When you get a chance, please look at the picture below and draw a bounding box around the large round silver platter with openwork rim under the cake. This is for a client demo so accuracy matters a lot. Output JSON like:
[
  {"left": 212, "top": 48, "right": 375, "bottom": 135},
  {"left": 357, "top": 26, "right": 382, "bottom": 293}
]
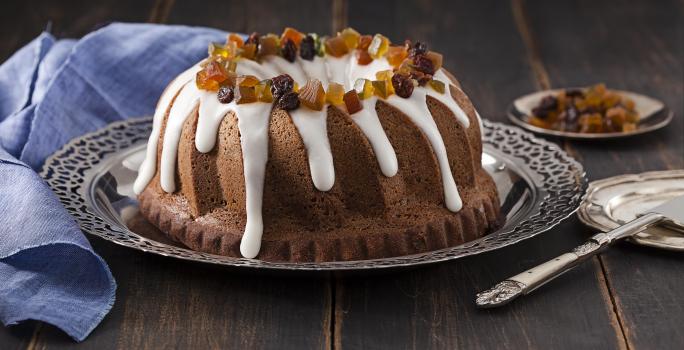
[{"left": 41, "top": 117, "right": 587, "bottom": 270}]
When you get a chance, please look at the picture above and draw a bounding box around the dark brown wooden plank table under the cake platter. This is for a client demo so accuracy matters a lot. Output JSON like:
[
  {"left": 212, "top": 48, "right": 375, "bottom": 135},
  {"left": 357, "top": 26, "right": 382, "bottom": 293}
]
[{"left": 0, "top": 0, "right": 684, "bottom": 350}]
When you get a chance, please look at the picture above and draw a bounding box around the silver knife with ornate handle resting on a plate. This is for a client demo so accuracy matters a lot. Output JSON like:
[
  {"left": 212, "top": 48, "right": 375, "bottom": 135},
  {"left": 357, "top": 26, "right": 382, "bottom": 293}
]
[{"left": 475, "top": 196, "right": 684, "bottom": 308}]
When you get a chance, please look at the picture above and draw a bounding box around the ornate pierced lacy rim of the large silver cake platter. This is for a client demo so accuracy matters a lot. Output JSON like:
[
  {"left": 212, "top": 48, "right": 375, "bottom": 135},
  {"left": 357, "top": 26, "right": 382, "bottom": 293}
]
[{"left": 40, "top": 117, "right": 587, "bottom": 271}]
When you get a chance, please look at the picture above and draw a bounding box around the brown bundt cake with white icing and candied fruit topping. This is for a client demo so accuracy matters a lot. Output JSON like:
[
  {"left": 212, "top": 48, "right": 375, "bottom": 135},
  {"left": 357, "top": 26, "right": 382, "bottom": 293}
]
[{"left": 134, "top": 28, "right": 499, "bottom": 262}]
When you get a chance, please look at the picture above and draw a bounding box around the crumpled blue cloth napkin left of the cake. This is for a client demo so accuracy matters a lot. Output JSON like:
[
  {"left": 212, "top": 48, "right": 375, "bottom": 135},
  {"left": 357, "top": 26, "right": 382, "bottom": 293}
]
[{"left": 0, "top": 23, "right": 225, "bottom": 341}]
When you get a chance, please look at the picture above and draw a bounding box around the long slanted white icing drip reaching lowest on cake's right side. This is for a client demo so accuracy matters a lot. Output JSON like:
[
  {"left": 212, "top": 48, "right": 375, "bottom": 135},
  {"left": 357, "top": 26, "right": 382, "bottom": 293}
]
[{"left": 387, "top": 88, "right": 463, "bottom": 212}]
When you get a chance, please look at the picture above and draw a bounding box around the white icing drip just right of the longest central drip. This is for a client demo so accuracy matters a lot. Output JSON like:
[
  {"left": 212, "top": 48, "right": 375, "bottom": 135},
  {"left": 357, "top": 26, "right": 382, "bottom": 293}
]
[{"left": 289, "top": 108, "right": 335, "bottom": 191}]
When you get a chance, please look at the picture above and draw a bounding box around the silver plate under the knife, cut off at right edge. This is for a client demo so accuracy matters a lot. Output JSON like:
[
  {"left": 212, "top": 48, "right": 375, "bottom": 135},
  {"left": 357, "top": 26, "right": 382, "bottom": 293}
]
[{"left": 577, "top": 170, "right": 684, "bottom": 251}]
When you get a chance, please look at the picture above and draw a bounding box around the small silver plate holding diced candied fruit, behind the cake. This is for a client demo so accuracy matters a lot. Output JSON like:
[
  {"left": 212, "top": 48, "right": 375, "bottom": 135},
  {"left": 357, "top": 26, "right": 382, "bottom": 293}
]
[{"left": 507, "top": 88, "right": 674, "bottom": 139}]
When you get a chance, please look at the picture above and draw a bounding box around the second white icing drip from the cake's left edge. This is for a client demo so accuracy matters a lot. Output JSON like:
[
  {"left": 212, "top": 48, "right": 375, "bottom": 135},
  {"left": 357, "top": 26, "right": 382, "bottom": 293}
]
[{"left": 159, "top": 81, "right": 200, "bottom": 193}]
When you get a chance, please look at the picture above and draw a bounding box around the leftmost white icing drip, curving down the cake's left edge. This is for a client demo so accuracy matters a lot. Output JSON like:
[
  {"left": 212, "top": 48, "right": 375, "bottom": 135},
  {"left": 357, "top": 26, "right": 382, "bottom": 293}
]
[{"left": 133, "top": 66, "right": 201, "bottom": 194}]
